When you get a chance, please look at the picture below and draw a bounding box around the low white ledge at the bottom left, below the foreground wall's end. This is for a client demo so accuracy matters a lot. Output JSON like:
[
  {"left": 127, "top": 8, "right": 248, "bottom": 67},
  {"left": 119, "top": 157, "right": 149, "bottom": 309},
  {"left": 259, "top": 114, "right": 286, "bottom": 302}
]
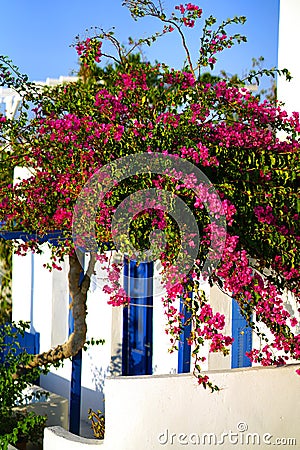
[{"left": 44, "top": 427, "right": 104, "bottom": 450}]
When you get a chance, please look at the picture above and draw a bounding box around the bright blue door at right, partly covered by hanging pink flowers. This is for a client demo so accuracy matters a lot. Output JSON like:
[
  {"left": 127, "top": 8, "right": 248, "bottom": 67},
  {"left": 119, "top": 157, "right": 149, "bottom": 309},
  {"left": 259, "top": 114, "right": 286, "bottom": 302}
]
[{"left": 231, "top": 299, "right": 252, "bottom": 369}]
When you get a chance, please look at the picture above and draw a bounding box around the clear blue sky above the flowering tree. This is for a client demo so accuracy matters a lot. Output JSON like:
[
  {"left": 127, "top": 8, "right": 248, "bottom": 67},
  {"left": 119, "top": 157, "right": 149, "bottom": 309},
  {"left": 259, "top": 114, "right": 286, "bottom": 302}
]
[{"left": 0, "top": 0, "right": 279, "bottom": 80}]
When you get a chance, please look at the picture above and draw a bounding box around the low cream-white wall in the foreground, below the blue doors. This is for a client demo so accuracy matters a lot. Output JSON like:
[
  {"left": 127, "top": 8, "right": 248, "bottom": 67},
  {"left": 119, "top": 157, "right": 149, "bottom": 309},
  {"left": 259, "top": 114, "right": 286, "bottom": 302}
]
[{"left": 44, "top": 365, "right": 300, "bottom": 450}]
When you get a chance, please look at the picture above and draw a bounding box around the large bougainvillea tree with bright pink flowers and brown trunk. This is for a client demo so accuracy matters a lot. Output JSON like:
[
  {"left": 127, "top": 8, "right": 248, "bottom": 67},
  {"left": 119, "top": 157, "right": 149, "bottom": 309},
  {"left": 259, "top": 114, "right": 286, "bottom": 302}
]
[{"left": 0, "top": 0, "right": 300, "bottom": 389}]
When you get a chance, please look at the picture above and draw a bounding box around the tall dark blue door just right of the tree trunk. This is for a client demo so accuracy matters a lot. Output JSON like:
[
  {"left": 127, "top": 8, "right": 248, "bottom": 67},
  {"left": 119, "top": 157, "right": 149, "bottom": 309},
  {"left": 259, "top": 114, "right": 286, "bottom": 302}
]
[{"left": 122, "top": 260, "right": 153, "bottom": 375}]
